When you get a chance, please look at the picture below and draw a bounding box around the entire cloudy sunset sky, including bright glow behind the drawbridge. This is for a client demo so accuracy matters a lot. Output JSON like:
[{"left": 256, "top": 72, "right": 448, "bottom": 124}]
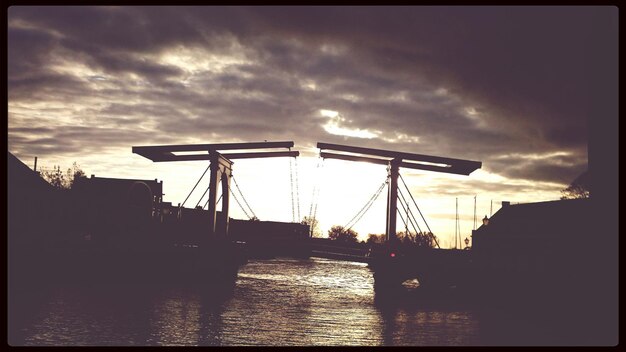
[{"left": 7, "top": 6, "right": 617, "bottom": 247}]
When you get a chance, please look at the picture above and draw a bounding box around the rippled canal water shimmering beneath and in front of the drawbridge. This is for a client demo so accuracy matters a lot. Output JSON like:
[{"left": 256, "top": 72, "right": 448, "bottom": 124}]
[{"left": 9, "top": 258, "right": 482, "bottom": 346}]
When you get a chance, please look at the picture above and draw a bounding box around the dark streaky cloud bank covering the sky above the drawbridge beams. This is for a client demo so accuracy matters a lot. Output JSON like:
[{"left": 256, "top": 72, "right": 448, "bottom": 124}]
[{"left": 8, "top": 7, "right": 601, "bottom": 191}]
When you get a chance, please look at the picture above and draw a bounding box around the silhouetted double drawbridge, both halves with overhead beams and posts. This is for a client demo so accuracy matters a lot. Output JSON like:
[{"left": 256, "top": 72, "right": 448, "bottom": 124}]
[{"left": 132, "top": 141, "right": 481, "bottom": 285}]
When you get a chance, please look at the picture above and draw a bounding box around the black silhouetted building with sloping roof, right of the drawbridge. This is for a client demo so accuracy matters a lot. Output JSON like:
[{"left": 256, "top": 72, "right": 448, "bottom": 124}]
[{"left": 472, "top": 199, "right": 601, "bottom": 279}]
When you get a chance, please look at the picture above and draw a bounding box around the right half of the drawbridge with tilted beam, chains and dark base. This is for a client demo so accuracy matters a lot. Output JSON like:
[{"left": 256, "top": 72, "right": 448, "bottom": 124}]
[{"left": 317, "top": 143, "right": 482, "bottom": 287}]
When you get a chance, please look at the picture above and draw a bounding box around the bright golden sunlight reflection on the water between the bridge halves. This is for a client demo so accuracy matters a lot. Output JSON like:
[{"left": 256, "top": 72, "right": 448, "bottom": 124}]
[{"left": 227, "top": 259, "right": 378, "bottom": 345}]
